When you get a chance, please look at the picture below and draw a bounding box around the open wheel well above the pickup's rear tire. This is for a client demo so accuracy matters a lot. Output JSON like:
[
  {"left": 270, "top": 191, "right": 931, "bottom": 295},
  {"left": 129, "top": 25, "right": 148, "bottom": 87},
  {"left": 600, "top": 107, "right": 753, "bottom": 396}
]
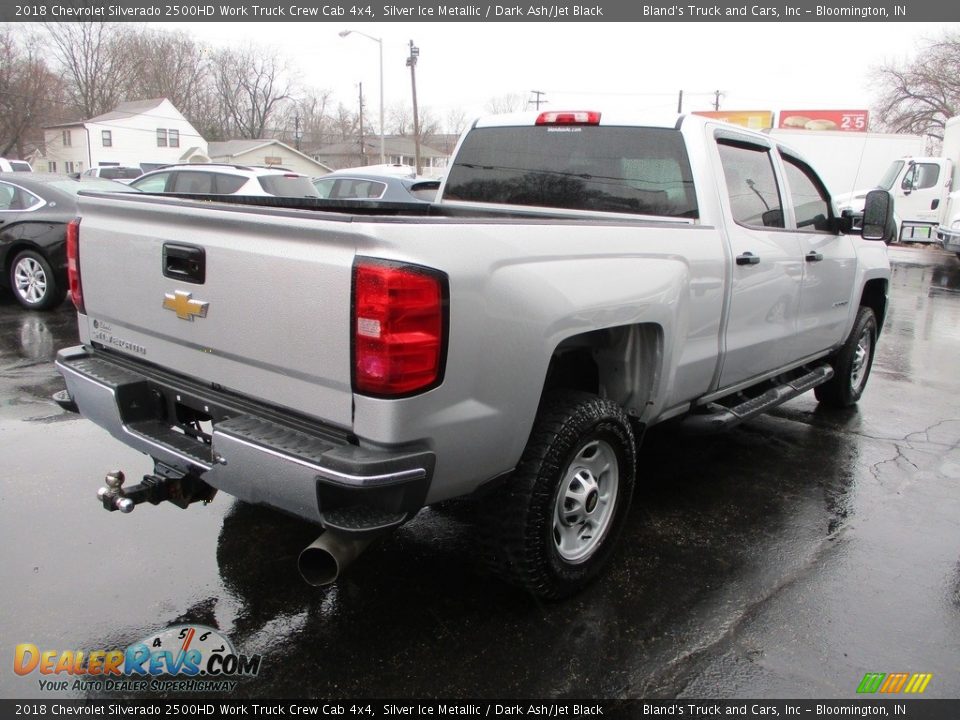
[{"left": 543, "top": 324, "right": 663, "bottom": 417}]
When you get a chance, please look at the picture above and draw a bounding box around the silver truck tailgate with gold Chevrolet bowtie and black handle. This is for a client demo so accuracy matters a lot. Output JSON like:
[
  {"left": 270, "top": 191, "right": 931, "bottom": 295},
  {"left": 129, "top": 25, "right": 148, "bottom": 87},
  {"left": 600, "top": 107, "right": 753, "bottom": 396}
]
[{"left": 80, "top": 196, "right": 355, "bottom": 427}]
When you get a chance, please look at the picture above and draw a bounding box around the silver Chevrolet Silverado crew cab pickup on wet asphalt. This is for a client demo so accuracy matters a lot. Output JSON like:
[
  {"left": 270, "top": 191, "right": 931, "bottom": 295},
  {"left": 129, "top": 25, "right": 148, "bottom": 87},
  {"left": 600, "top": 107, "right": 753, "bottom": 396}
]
[{"left": 57, "top": 112, "right": 892, "bottom": 598}]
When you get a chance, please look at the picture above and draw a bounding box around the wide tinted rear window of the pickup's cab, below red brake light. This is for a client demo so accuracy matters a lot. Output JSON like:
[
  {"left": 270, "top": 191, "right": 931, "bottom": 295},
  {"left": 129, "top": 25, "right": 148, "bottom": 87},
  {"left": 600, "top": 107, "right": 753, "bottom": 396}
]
[{"left": 444, "top": 126, "right": 699, "bottom": 218}]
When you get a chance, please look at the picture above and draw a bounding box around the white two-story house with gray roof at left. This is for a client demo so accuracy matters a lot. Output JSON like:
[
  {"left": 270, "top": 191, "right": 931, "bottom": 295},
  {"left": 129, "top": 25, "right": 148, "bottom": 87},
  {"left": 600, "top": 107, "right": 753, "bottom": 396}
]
[{"left": 42, "top": 98, "right": 207, "bottom": 173}]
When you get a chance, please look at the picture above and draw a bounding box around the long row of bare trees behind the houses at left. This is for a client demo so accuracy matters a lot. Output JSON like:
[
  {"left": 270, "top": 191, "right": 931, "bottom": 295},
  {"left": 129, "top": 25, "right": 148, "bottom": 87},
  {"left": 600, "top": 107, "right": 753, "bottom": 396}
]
[{"left": 0, "top": 22, "right": 466, "bottom": 157}]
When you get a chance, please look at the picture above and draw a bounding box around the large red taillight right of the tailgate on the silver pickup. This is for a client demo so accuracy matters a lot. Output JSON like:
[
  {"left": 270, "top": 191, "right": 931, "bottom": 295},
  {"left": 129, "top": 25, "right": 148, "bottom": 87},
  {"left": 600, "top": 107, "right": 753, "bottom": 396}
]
[{"left": 353, "top": 261, "right": 447, "bottom": 397}]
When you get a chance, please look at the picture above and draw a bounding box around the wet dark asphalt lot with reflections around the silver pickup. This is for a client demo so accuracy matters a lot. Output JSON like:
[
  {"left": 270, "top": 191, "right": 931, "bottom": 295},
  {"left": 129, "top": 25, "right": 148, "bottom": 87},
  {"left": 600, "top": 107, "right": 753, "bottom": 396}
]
[{"left": 0, "top": 248, "right": 960, "bottom": 700}]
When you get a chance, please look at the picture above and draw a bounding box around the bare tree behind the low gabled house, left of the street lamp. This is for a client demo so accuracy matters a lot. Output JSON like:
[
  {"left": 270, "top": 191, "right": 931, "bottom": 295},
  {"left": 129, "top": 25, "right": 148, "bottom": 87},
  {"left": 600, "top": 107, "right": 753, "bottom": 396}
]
[{"left": 211, "top": 45, "right": 291, "bottom": 138}]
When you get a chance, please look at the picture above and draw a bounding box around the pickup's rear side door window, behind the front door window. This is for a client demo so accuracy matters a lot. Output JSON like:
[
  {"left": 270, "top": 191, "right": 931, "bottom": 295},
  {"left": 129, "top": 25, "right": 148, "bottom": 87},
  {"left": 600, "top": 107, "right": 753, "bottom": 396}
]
[{"left": 717, "top": 140, "right": 784, "bottom": 228}]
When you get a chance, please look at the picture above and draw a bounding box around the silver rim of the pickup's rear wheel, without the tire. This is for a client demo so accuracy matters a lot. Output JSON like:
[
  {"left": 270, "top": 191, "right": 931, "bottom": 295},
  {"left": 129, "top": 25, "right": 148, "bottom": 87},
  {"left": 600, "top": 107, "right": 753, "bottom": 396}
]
[{"left": 553, "top": 440, "right": 620, "bottom": 563}]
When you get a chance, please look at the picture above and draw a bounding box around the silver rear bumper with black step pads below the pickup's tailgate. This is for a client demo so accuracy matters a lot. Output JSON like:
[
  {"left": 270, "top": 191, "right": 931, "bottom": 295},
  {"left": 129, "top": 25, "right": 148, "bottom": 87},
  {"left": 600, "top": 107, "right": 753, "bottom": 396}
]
[{"left": 57, "top": 346, "right": 435, "bottom": 533}]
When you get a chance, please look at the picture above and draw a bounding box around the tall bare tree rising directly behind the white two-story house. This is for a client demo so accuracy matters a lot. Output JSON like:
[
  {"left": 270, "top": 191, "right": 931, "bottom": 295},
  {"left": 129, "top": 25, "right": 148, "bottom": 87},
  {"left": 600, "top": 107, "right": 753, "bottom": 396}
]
[{"left": 45, "top": 22, "right": 138, "bottom": 118}]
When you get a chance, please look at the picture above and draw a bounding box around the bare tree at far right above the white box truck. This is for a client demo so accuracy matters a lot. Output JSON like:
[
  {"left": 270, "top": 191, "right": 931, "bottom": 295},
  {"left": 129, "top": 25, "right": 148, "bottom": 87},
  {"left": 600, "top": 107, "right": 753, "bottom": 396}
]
[{"left": 874, "top": 31, "right": 960, "bottom": 140}]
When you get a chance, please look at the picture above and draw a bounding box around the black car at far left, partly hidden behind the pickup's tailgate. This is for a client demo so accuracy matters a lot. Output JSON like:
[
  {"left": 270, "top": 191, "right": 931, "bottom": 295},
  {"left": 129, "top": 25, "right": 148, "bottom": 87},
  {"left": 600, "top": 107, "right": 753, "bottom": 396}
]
[{"left": 0, "top": 173, "right": 137, "bottom": 310}]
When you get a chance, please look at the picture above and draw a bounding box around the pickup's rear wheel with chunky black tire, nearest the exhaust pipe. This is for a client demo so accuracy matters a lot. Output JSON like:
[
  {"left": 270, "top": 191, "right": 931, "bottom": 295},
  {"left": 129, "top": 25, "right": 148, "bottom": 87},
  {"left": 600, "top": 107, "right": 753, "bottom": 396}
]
[{"left": 481, "top": 392, "right": 636, "bottom": 600}]
